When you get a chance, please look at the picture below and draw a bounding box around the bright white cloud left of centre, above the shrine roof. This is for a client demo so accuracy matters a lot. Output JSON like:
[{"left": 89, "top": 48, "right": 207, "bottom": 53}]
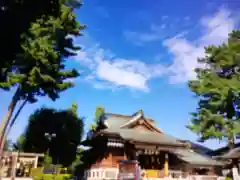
[{"left": 76, "top": 45, "right": 167, "bottom": 92}]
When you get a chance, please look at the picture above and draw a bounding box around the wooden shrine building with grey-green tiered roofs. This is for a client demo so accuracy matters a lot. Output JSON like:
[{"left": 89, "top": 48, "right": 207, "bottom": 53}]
[{"left": 82, "top": 110, "right": 223, "bottom": 179}]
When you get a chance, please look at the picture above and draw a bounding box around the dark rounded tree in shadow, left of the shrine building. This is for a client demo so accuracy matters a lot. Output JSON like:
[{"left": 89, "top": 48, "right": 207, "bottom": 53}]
[{"left": 23, "top": 108, "right": 84, "bottom": 166}]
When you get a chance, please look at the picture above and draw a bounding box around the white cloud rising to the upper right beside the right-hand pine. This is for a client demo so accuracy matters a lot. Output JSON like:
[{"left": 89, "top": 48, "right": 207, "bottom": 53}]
[{"left": 163, "top": 8, "right": 237, "bottom": 83}]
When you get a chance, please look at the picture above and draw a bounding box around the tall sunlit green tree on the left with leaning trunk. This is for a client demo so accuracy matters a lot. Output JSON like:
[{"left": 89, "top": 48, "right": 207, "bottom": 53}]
[{"left": 0, "top": 0, "right": 84, "bottom": 154}]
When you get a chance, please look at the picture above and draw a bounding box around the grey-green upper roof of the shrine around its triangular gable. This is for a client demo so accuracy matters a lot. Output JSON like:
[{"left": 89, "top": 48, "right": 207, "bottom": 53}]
[{"left": 98, "top": 110, "right": 185, "bottom": 145}]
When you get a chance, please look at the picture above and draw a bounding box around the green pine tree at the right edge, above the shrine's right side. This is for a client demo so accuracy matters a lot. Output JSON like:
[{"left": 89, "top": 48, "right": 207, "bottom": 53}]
[{"left": 188, "top": 31, "right": 240, "bottom": 149}]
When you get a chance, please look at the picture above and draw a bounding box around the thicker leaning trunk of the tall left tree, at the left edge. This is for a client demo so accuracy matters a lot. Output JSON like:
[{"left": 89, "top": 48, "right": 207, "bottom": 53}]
[{"left": 0, "top": 88, "right": 20, "bottom": 158}]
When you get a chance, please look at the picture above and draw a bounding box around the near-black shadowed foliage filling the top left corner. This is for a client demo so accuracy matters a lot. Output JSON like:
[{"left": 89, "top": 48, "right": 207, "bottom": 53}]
[{"left": 0, "top": 0, "right": 79, "bottom": 82}]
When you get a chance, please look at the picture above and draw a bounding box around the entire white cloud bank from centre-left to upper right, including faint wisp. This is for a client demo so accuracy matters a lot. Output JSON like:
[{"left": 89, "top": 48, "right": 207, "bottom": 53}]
[{"left": 76, "top": 9, "right": 236, "bottom": 92}]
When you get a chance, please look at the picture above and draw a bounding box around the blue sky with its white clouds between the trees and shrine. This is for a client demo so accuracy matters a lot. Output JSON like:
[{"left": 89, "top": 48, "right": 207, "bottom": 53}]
[{"left": 0, "top": 0, "right": 240, "bottom": 148}]
